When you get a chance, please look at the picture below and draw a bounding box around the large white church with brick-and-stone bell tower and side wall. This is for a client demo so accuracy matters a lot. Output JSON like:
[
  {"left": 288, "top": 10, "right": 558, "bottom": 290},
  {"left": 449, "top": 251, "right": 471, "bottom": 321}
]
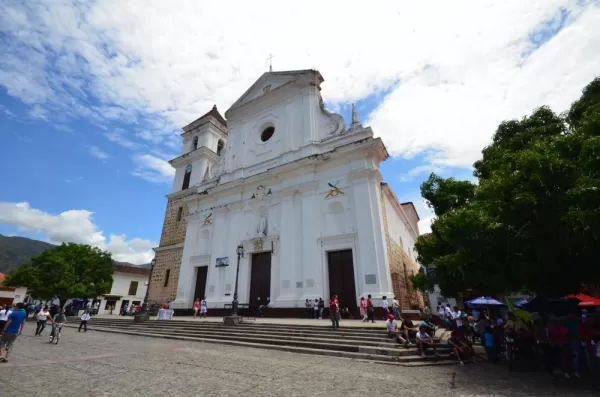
[{"left": 150, "top": 70, "right": 423, "bottom": 314}]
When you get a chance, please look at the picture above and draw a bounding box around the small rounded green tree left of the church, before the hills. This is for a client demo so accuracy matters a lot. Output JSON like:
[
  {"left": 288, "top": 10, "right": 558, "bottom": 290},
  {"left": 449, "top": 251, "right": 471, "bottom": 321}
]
[{"left": 4, "top": 243, "right": 114, "bottom": 306}]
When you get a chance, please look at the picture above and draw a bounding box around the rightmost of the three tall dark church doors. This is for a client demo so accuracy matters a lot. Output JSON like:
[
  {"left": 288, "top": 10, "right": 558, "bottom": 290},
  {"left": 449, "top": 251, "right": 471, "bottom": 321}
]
[{"left": 327, "top": 250, "right": 359, "bottom": 318}]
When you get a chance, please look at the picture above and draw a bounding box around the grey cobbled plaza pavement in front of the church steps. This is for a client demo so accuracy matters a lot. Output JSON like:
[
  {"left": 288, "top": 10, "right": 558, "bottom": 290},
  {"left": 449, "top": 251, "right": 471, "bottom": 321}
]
[{"left": 0, "top": 324, "right": 598, "bottom": 397}]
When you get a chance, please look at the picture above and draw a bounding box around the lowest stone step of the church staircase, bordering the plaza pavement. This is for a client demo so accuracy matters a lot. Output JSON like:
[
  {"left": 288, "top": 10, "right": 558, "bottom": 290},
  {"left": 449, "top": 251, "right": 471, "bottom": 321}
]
[{"left": 67, "top": 324, "right": 456, "bottom": 367}]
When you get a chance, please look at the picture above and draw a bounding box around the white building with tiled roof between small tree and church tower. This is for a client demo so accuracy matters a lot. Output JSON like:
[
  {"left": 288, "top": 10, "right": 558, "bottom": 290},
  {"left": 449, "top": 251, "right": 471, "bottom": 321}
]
[{"left": 98, "top": 263, "right": 150, "bottom": 315}]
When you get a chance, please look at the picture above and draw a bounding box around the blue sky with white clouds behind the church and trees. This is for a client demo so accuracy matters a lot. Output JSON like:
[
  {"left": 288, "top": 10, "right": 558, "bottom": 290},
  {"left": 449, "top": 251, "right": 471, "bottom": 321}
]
[{"left": 0, "top": 0, "right": 600, "bottom": 264}]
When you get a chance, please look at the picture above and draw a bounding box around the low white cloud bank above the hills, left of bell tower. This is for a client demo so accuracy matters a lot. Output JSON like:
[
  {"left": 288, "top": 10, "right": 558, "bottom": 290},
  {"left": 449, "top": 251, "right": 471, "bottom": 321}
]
[{"left": 0, "top": 202, "right": 158, "bottom": 264}]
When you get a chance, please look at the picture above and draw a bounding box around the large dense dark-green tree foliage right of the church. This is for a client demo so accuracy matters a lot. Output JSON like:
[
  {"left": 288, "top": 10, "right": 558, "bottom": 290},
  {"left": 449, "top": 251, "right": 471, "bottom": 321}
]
[{"left": 416, "top": 79, "right": 600, "bottom": 296}]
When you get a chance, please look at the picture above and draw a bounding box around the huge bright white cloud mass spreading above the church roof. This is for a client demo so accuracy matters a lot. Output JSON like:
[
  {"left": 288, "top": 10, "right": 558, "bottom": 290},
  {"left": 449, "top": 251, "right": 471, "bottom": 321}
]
[{"left": 0, "top": 0, "right": 600, "bottom": 167}]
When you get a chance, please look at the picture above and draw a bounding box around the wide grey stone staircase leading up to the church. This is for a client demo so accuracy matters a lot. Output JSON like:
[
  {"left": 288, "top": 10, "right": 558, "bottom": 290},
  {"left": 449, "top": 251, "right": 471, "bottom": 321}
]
[{"left": 67, "top": 317, "right": 456, "bottom": 366}]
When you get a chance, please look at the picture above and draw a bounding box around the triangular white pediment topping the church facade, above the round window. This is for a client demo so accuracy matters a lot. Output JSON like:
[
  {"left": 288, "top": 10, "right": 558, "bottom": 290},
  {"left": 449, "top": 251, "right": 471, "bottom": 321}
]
[{"left": 225, "top": 69, "right": 323, "bottom": 118}]
